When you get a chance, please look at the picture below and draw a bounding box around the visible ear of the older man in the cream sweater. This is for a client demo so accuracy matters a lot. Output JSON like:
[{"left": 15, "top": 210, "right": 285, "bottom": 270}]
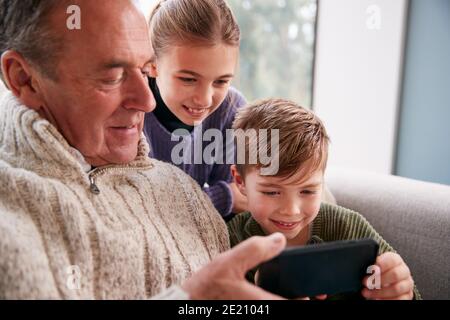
[{"left": 1, "top": 50, "right": 43, "bottom": 111}]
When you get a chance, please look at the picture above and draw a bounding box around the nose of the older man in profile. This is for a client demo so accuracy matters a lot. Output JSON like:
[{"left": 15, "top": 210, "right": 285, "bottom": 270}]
[{"left": 124, "top": 72, "right": 156, "bottom": 112}]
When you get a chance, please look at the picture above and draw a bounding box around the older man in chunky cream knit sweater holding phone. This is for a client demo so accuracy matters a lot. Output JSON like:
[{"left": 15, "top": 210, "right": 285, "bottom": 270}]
[{"left": 0, "top": 0, "right": 285, "bottom": 299}]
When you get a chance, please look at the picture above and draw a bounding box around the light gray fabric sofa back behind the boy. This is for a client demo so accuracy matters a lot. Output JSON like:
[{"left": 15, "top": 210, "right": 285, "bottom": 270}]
[{"left": 326, "top": 167, "right": 450, "bottom": 300}]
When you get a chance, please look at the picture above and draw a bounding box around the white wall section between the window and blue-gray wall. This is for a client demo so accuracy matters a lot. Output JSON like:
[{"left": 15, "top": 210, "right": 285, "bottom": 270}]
[{"left": 314, "top": 0, "right": 407, "bottom": 173}]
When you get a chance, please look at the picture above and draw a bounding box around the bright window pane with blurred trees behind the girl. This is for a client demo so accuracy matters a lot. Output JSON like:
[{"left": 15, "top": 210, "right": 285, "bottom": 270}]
[{"left": 227, "top": 0, "right": 317, "bottom": 107}]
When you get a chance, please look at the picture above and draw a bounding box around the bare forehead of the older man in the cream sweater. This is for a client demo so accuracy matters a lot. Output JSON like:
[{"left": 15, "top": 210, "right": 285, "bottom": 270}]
[{"left": 52, "top": 0, "right": 151, "bottom": 72}]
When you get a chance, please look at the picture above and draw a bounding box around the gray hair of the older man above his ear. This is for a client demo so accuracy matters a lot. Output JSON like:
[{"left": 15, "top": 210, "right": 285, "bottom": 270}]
[{"left": 0, "top": 0, "right": 63, "bottom": 84}]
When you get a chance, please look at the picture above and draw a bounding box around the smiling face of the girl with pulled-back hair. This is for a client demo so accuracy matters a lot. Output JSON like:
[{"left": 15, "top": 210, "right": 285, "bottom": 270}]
[{"left": 151, "top": 44, "right": 239, "bottom": 126}]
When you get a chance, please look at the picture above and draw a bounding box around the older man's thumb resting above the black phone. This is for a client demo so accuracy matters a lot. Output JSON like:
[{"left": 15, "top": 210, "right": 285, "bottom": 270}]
[{"left": 228, "top": 232, "right": 286, "bottom": 274}]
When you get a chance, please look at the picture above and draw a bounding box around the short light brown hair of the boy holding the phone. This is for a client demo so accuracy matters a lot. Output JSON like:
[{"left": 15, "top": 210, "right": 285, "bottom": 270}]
[{"left": 233, "top": 99, "right": 330, "bottom": 178}]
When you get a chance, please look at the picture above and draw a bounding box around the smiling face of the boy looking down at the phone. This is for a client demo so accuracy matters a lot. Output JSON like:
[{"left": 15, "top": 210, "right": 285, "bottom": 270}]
[{"left": 232, "top": 166, "right": 323, "bottom": 244}]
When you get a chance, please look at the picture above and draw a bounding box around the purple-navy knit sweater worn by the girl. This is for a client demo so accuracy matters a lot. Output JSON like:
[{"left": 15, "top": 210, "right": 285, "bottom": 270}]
[{"left": 144, "top": 81, "right": 246, "bottom": 219}]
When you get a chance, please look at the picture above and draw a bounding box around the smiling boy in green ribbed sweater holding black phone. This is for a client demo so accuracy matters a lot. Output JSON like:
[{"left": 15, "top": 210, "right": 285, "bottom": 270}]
[{"left": 228, "top": 99, "right": 420, "bottom": 300}]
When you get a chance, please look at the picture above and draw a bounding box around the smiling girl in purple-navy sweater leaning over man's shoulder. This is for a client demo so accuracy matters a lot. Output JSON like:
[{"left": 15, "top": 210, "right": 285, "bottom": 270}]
[{"left": 144, "top": 0, "right": 246, "bottom": 219}]
